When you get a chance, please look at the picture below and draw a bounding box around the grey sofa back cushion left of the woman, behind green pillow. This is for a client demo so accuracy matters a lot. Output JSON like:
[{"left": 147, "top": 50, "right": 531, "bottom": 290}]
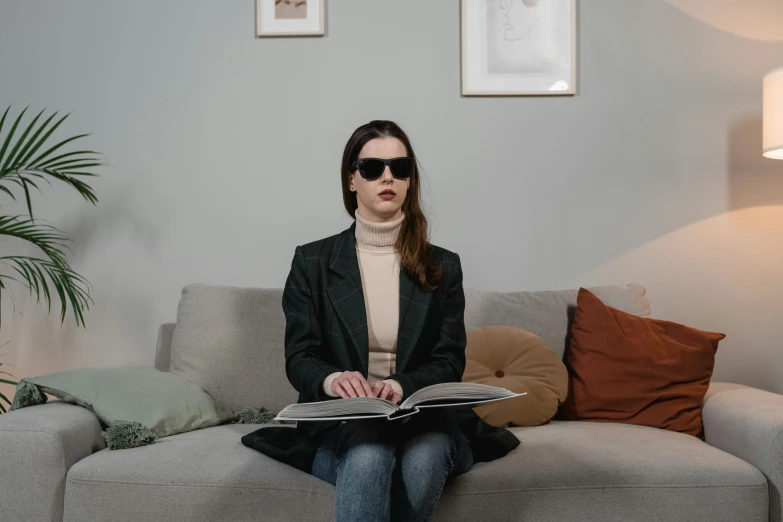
[{"left": 170, "top": 284, "right": 297, "bottom": 411}]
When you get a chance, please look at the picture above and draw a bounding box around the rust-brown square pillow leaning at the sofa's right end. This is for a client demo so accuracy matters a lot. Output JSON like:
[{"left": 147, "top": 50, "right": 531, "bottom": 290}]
[{"left": 560, "top": 288, "right": 726, "bottom": 439}]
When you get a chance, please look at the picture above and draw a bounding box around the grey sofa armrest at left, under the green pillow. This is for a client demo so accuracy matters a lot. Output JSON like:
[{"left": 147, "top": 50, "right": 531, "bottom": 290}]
[{"left": 0, "top": 401, "right": 106, "bottom": 520}]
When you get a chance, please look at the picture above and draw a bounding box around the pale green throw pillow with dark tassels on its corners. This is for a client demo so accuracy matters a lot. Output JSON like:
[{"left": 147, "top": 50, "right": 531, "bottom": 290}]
[{"left": 11, "top": 366, "right": 264, "bottom": 449}]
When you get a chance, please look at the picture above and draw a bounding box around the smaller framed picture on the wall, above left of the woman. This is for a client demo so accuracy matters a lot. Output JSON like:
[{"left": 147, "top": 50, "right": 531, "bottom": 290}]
[{"left": 256, "top": 0, "right": 326, "bottom": 36}]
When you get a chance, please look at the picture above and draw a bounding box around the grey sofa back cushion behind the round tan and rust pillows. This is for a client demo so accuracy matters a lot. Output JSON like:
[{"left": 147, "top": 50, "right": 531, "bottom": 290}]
[{"left": 465, "top": 284, "right": 650, "bottom": 359}]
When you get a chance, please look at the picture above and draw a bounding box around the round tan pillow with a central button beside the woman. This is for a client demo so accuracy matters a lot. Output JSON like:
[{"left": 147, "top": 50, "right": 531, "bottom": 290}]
[{"left": 462, "top": 326, "right": 568, "bottom": 426}]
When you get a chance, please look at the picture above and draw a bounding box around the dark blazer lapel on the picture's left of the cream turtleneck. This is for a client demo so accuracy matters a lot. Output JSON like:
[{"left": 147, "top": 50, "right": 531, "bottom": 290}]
[{"left": 326, "top": 222, "right": 370, "bottom": 377}]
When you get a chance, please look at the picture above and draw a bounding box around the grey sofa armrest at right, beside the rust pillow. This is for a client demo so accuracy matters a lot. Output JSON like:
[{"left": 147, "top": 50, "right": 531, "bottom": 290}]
[{"left": 702, "top": 382, "right": 783, "bottom": 522}]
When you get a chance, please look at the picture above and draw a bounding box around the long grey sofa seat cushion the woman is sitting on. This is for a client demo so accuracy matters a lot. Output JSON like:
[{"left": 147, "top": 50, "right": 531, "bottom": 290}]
[{"left": 65, "top": 422, "right": 768, "bottom": 522}]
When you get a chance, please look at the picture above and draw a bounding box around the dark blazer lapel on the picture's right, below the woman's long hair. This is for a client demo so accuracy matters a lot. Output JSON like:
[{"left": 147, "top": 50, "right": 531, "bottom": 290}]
[{"left": 396, "top": 267, "right": 432, "bottom": 372}]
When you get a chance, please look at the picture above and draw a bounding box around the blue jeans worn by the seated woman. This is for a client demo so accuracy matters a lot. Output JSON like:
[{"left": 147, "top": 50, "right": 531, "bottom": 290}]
[{"left": 312, "top": 408, "right": 473, "bottom": 522}]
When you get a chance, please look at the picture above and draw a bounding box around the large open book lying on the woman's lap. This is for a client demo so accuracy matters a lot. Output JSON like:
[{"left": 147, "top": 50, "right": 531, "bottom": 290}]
[{"left": 274, "top": 382, "right": 527, "bottom": 421}]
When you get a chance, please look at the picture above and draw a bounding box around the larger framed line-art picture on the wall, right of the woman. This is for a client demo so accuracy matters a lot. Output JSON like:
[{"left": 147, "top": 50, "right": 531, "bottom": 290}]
[{"left": 461, "top": 0, "right": 577, "bottom": 96}]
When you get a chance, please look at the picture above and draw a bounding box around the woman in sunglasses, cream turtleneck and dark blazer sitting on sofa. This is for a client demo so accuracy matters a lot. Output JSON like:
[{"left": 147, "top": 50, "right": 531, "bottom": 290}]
[{"left": 242, "top": 121, "right": 519, "bottom": 521}]
